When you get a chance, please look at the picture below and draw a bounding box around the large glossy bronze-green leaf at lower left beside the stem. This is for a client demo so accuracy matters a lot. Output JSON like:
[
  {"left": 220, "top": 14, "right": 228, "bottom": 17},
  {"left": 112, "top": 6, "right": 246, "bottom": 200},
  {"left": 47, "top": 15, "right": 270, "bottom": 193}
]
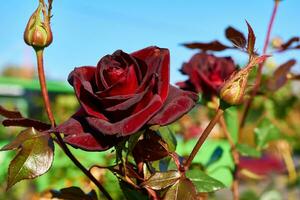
[{"left": 6, "top": 128, "right": 54, "bottom": 189}]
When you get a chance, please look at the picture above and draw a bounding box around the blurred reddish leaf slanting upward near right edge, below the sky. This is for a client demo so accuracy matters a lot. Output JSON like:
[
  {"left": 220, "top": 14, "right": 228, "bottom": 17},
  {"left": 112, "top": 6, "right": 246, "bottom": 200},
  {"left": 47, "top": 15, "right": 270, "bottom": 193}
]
[{"left": 267, "top": 59, "right": 296, "bottom": 91}]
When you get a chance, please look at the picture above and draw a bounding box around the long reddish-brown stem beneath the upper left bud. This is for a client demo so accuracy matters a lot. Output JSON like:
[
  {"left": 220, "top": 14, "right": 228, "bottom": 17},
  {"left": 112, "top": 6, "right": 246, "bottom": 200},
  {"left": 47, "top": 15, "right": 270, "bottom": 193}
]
[{"left": 35, "top": 49, "right": 112, "bottom": 200}]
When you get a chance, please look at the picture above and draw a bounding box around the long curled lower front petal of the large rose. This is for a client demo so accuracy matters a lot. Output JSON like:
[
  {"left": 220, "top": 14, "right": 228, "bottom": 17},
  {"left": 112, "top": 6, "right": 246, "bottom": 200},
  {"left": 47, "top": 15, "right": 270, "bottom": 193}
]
[{"left": 86, "top": 95, "right": 162, "bottom": 136}]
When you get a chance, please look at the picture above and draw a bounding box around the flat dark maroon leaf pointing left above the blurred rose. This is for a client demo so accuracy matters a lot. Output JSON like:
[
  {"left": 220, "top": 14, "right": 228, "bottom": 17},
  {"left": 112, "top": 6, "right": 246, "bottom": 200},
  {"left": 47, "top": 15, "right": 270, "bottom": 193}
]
[{"left": 183, "top": 40, "right": 232, "bottom": 51}]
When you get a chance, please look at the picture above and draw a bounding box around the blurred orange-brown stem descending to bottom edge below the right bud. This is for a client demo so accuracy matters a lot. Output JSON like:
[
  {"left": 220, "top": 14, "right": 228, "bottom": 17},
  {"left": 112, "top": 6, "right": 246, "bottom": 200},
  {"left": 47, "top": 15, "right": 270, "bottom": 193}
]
[{"left": 219, "top": 115, "right": 240, "bottom": 200}]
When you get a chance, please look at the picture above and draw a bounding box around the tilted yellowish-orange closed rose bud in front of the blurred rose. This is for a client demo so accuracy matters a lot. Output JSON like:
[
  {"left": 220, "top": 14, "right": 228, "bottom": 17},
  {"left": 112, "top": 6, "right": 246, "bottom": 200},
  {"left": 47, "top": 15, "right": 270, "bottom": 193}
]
[{"left": 220, "top": 55, "right": 268, "bottom": 105}]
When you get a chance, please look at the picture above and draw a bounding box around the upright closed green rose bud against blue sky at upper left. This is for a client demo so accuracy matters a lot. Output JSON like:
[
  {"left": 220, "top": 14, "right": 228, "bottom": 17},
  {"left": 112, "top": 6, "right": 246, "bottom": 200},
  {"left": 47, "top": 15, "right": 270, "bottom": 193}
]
[{"left": 24, "top": 1, "right": 53, "bottom": 49}]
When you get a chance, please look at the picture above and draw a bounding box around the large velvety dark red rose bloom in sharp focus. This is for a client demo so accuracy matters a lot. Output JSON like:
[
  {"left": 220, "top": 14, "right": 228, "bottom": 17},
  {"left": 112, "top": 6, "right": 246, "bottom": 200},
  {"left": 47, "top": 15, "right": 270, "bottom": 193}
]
[{"left": 56, "top": 47, "right": 197, "bottom": 150}]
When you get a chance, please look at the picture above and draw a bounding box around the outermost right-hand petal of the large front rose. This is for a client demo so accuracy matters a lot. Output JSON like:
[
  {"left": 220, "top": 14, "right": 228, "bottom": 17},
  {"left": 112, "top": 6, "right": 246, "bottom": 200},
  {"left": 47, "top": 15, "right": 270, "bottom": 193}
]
[{"left": 147, "top": 85, "right": 198, "bottom": 126}]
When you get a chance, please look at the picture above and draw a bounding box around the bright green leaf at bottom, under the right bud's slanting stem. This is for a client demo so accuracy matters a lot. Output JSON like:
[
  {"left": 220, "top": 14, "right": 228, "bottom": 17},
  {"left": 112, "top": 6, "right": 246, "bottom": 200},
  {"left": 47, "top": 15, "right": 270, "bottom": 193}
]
[{"left": 186, "top": 169, "right": 225, "bottom": 192}]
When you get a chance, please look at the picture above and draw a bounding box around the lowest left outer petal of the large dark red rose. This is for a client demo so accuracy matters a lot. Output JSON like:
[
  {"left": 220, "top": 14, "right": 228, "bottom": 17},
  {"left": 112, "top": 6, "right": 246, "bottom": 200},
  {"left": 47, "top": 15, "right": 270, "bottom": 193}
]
[{"left": 55, "top": 110, "right": 121, "bottom": 151}]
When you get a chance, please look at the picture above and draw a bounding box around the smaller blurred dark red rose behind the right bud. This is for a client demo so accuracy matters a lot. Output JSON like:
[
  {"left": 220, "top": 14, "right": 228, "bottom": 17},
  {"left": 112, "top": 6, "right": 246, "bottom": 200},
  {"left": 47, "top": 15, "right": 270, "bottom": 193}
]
[{"left": 176, "top": 53, "right": 237, "bottom": 97}]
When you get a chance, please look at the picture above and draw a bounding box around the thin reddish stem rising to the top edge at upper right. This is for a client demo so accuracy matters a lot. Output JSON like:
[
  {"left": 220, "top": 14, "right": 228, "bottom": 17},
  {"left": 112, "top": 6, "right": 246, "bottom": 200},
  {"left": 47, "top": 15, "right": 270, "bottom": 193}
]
[{"left": 239, "top": 0, "right": 279, "bottom": 132}]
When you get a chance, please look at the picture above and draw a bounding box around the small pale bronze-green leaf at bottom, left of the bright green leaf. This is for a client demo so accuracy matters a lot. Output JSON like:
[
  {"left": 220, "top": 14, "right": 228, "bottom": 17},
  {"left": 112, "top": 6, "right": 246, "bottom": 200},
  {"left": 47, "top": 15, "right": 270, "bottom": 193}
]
[{"left": 142, "top": 170, "right": 180, "bottom": 190}]
